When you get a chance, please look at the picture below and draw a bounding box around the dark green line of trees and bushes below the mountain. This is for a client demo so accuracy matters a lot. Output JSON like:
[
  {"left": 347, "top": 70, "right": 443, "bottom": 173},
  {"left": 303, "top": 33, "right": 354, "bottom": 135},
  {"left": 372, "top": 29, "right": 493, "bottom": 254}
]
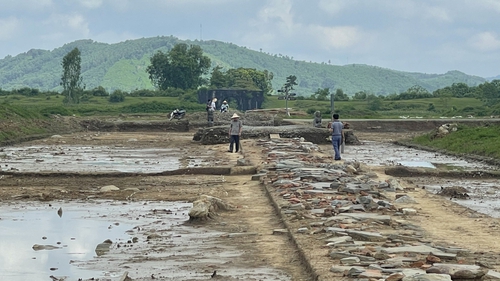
[{"left": 0, "top": 43, "right": 500, "bottom": 114}]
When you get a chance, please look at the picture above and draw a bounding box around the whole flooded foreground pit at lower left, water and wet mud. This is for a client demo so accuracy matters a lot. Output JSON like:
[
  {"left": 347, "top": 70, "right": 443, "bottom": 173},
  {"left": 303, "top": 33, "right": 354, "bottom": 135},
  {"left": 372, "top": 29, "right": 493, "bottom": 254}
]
[{"left": 0, "top": 201, "right": 290, "bottom": 281}]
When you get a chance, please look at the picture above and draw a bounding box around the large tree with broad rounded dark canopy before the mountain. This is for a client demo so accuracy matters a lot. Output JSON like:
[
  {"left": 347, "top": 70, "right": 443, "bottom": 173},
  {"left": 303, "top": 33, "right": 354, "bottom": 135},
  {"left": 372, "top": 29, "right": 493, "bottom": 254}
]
[{"left": 146, "top": 43, "right": 210, "bottom": 90}]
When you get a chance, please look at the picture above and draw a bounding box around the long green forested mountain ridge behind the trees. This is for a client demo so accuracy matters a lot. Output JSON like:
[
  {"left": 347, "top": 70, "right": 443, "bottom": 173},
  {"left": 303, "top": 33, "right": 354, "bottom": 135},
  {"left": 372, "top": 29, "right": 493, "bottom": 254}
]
[{"left": 0, "top": 36, "right": 486, "bottom": 96}]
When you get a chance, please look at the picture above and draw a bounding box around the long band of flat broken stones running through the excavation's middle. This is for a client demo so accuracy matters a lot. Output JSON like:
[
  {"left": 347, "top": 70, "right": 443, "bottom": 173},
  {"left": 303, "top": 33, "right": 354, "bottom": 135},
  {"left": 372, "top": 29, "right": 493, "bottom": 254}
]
[{"left": 253, "top": 136, "right": 500, "bottom": 281}]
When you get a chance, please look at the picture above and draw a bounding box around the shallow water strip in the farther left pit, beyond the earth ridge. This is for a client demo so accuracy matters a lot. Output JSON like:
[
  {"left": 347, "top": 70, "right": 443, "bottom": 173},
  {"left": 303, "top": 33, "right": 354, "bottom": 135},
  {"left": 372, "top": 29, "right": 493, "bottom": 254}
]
[{"left": 0, "top": 145, "right": 217, "bottom": 173}]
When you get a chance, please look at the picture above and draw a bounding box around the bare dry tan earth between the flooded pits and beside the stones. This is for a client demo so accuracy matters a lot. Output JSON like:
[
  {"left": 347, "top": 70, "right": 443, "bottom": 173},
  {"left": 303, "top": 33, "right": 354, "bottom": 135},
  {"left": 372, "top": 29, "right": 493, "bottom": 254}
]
[{"left": 0, "top": 132, "right": 500, "bottom": 281}]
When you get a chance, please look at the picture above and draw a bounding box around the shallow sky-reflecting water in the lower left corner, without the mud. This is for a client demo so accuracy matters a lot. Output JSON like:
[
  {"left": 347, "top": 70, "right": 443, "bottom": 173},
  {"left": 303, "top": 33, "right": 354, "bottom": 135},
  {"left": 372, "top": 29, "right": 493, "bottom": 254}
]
[{"left": 0, "top": 202, "right": 191, "bottom": 281}]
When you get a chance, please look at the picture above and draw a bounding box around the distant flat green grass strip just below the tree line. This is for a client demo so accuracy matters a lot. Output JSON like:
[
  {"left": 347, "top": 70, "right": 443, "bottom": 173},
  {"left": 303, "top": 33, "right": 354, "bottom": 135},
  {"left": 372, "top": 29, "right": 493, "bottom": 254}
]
[{"left": 0, "top": 95, "right": 487, "bottom": 119}]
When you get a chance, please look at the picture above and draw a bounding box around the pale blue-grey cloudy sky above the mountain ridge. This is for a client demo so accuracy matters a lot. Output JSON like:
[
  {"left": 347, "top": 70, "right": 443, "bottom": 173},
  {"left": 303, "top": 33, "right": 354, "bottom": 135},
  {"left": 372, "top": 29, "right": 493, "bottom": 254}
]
[{"left": 0, "top": 0, "right": 500, "bottom": 77}]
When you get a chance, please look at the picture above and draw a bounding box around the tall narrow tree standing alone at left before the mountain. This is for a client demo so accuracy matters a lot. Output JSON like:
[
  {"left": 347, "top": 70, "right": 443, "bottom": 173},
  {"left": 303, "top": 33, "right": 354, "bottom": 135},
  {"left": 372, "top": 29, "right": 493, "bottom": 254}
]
[{"left": 61, "top": 48, "right": 83, "bottom": 104}]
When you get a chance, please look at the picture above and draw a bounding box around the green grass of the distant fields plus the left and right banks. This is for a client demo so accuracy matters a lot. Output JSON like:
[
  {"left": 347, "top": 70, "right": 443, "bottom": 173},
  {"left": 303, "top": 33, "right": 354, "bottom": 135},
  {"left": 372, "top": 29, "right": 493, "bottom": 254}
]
[{"left": 0, "top": 95, "right": 500, "bottom": 162}]
